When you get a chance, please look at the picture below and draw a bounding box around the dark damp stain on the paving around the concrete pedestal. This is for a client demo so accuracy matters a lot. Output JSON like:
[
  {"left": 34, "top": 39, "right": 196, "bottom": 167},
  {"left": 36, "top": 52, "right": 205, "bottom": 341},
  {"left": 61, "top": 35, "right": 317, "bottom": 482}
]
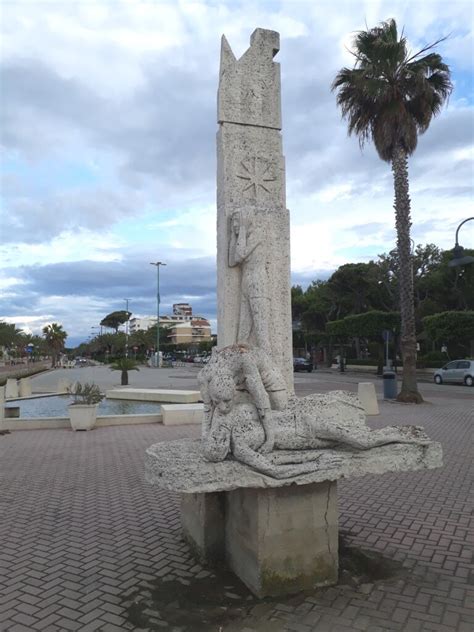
[{"left": 122, "top": 537, "right": 409, "bottom": 632}]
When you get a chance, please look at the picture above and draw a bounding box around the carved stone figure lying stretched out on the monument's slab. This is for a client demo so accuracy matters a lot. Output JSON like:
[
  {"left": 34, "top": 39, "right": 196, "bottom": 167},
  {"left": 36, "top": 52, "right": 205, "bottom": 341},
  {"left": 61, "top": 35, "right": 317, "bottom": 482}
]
[{"left": 202, "top": 381, "right": 430, "bottom": 478}]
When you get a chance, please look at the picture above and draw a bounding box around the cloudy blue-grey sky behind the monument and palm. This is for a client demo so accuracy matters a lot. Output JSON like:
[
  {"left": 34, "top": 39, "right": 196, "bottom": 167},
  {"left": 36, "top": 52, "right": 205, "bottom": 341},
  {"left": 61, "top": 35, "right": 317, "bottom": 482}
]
[{"left": 0, "top": 0, "right": 474, "bottom": 345}]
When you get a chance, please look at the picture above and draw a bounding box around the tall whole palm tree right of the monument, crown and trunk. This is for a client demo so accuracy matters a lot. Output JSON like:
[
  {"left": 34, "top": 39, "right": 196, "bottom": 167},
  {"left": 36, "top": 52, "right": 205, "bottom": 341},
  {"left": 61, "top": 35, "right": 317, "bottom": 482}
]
[{"left": 332, "top": 19, "right": 452, "bottom": 403}]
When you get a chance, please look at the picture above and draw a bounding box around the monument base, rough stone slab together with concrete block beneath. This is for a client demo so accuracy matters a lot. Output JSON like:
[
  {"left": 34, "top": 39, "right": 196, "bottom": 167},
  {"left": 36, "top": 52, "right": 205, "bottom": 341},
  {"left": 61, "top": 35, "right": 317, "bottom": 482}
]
[{"left": 145, "top": 439, "right": 442, "bottom": 597}]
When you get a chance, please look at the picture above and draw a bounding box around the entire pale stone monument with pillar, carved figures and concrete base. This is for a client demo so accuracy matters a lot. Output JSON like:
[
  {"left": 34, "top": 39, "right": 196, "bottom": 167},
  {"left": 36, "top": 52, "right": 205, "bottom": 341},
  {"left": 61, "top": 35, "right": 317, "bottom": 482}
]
[{"left": 146, "top": 29, "right": 442, "bottom": 597}]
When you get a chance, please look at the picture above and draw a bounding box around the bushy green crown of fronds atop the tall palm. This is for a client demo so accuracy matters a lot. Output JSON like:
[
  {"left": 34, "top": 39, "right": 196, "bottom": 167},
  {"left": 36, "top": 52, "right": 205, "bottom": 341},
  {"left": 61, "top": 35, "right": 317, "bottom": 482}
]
[{"left": 331, "top": 19, "right": 453, "bottom": 161}]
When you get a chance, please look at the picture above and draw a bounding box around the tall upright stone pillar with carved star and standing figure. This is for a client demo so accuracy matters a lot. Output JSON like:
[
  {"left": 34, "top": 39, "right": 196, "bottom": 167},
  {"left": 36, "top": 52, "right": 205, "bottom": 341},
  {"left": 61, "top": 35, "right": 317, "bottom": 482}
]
[{"left": 217, "top": 29, "right": 293, "bottom": 392}]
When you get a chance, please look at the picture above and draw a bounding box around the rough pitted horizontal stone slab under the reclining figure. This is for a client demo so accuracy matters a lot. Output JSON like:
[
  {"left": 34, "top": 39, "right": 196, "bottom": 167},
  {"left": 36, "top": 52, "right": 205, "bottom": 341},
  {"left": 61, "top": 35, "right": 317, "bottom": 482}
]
[{"left": 145, "top": 439, "right": 442, "bottom": 494}]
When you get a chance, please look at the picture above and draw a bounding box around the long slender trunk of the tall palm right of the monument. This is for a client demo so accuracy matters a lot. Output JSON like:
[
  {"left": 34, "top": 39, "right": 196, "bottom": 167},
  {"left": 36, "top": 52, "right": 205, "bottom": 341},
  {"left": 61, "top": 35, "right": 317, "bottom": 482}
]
[{"left": 392, "top": 146, "right": 423, "bottom": 404}]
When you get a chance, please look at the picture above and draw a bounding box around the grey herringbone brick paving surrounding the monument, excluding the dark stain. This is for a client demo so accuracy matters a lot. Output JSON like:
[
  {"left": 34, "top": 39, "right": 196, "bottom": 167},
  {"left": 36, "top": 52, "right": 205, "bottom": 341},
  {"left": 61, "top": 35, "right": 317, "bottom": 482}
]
[{"left": 0, "top": 382, "right": 474, "bottom": 632}]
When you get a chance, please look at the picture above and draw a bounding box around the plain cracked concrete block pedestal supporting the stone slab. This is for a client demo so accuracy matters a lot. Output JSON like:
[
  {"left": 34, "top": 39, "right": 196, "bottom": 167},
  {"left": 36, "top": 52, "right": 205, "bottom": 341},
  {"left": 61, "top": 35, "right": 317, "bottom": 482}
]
[{"left": 181, "top": 481, "right": 338, "bottom": 597}]
